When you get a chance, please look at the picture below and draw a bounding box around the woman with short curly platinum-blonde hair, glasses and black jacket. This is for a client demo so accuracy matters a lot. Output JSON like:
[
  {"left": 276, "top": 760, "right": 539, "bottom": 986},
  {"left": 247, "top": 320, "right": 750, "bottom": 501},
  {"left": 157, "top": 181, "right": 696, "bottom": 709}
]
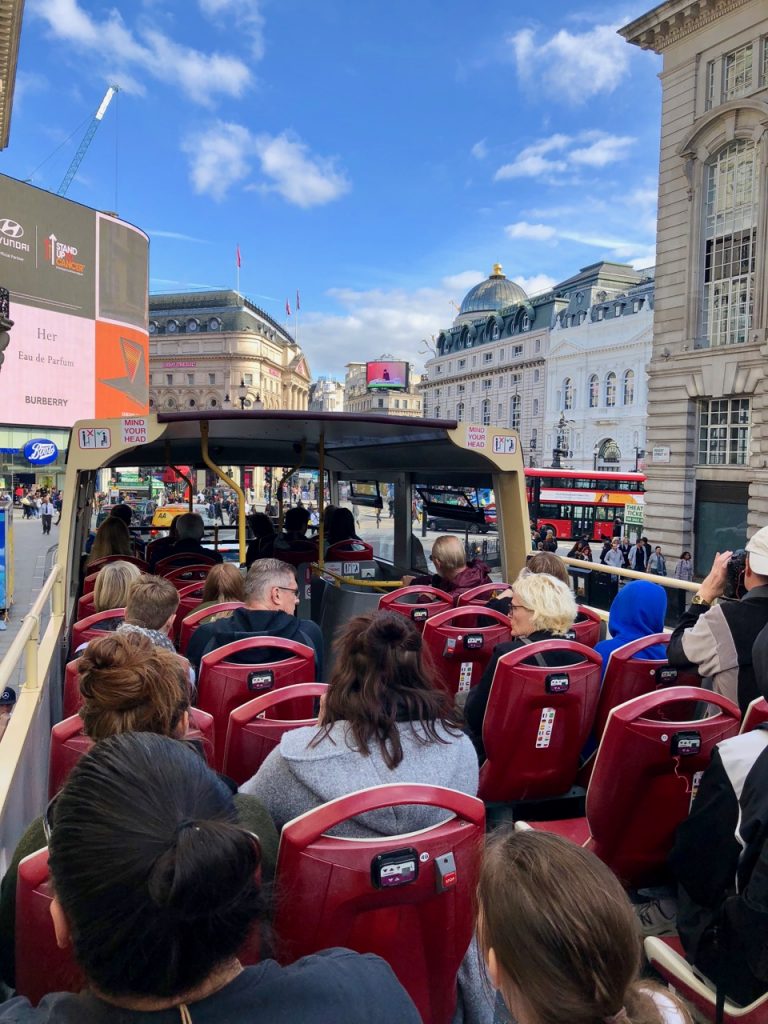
[{"left": 464, "top": 572, "right": 581, "bottom": 761}]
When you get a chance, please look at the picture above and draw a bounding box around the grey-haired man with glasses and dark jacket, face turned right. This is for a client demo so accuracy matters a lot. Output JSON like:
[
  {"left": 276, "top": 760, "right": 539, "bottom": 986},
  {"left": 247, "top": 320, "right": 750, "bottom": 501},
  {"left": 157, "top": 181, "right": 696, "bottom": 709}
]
[{"left": 186, "top": 558, "right": 323, "bottom": 680}]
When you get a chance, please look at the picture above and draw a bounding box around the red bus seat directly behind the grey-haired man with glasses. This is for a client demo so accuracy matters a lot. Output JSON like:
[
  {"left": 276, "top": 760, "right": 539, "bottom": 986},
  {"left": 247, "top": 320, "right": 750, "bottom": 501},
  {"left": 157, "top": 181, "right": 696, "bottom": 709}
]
[{"left": 197, "top": 637, "right": 315, "bottom": 771}]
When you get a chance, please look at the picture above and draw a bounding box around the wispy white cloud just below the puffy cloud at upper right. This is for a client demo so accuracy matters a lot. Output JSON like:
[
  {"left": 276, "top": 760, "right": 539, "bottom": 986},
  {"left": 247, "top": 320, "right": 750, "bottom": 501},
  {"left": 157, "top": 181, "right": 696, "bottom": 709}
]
[{"left": 494, "top": 131, "right": 636, "bottom": 181}]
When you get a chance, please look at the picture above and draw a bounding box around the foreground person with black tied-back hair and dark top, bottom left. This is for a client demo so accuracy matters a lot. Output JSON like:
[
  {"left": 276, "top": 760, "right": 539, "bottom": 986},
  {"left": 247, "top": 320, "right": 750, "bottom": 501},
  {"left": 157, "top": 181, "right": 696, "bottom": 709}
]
[{"left": 0, "top": 733, "right": 419, "bottom": 1024}]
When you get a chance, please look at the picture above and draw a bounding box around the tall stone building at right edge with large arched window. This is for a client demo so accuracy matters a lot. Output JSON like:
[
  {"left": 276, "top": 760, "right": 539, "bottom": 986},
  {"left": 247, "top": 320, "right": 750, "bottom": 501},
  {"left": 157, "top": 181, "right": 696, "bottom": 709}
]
[{"left": 622, "top": 0, "right": 768, "bottom": 573}]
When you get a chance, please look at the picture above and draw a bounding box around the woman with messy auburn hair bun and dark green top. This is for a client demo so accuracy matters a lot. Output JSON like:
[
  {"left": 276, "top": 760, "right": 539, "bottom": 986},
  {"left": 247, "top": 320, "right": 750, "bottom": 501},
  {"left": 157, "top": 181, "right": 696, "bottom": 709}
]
[{"left": 0, "top": 633, "right": 278, "bottom": 986}]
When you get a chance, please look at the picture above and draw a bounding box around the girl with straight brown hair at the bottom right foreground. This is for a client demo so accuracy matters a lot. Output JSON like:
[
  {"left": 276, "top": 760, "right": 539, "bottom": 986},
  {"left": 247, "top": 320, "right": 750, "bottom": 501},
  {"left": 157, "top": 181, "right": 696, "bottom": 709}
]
[{"left": 477, "top": 829, "right": 690, "bottom": 1024}]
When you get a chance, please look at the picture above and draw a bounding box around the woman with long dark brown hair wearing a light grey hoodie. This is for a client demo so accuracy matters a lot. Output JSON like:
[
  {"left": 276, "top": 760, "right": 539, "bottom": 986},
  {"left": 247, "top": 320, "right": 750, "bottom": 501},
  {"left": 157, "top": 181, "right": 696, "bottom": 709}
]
[{"left": 241, "top": 611, "right": 477, "bottom": 839}]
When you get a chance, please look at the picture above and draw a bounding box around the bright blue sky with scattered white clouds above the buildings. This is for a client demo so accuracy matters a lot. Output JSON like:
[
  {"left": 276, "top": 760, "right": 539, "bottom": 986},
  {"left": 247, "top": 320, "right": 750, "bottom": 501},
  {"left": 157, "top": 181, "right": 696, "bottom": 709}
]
[{"left": 0, "top": 0, "right": 660, "bottom": 376}]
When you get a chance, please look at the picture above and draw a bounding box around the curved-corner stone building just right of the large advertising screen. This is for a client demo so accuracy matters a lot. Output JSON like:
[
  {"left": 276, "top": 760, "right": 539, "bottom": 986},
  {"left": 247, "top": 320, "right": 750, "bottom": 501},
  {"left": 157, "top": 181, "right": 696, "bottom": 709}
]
[{"left": 150, "top": 291, "right": 311, "bottom": 412}]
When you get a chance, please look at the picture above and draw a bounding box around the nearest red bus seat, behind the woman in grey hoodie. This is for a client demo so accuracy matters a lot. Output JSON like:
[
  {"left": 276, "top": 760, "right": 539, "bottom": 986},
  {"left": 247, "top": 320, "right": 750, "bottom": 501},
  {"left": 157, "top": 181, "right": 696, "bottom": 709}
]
[{"left": 274, "top": 784, "right": 485, "bottom": 1024}]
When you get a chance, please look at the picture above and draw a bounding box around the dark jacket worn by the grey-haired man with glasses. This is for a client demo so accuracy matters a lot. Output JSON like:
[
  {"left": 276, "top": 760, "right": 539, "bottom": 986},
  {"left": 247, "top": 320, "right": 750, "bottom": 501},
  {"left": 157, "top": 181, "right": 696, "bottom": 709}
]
[{"left": 192, "top": 608, "right": 323, "bottom": 680}]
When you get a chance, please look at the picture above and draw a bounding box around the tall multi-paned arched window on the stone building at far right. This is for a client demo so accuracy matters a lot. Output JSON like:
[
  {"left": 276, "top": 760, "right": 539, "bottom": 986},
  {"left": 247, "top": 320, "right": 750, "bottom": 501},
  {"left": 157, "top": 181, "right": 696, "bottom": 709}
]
[{"left": 701, "top": 139, "right": 760, "bottom": 345}]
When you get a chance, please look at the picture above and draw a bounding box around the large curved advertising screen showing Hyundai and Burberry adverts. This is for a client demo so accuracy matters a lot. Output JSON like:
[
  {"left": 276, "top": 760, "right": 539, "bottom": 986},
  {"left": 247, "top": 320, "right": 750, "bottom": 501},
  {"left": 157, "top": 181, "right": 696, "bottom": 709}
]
[{"left": 0, "top": 175, "right": 150, "bottom": 427}]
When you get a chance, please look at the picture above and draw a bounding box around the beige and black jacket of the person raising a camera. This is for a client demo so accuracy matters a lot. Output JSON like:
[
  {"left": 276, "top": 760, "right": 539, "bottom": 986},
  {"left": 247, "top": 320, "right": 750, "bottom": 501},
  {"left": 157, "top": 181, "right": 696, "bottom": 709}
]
[{"left": 667, "top": 586, "right": 768, "bottom": 714}]
